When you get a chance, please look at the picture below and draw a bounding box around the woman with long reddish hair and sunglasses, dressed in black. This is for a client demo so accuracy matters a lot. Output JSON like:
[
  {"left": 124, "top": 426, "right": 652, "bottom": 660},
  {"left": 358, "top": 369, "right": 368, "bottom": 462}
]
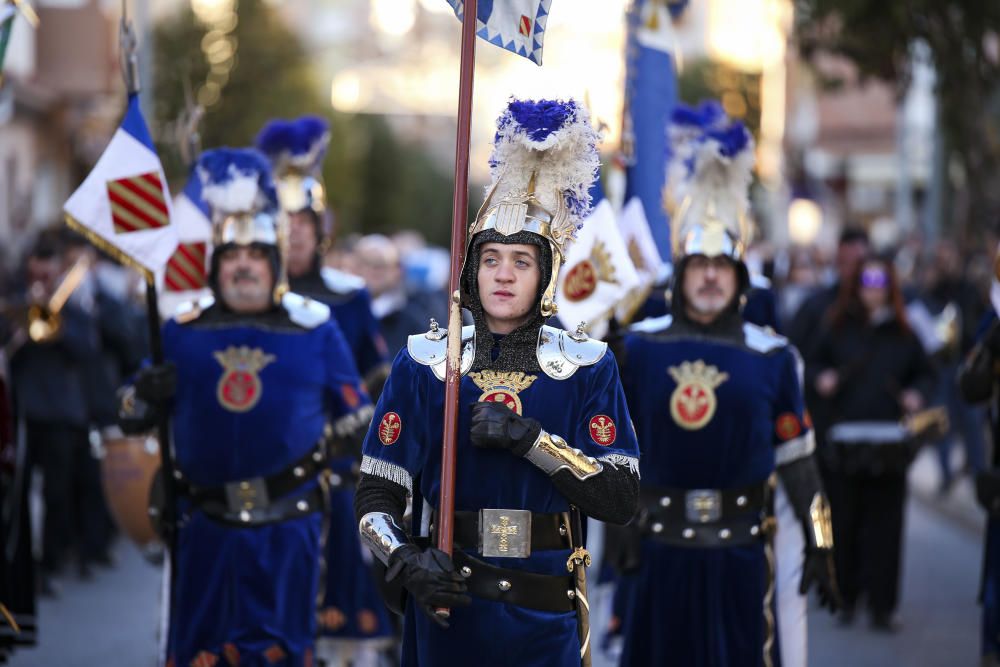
[{"left": 806, "top": 254, "right": 934, "bottom": 631}]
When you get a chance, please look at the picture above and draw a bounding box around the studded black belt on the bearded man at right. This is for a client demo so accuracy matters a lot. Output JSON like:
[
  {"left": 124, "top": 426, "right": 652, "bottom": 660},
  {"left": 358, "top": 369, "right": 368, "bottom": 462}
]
[{"left": 640, "top": 480, "right": 774, "bottom": 547}]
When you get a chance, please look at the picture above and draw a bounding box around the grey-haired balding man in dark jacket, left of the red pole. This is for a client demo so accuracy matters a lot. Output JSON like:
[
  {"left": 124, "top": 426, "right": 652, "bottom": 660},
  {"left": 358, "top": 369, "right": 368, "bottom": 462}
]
[{"left": 354, "top": 234, "right": 431, "bottom": 356}]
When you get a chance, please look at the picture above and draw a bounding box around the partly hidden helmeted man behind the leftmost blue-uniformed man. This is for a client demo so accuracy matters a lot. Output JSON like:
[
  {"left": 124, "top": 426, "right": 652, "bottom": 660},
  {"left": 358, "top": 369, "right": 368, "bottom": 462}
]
[{"left": 257, "top": 116, "right": 394, "bottom": 665}]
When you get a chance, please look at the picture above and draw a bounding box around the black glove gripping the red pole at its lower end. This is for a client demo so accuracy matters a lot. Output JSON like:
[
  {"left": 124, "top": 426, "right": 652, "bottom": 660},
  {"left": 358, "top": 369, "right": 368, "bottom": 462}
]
[{"left": 385, "top": 544, "right": 472, "bottom": 628}]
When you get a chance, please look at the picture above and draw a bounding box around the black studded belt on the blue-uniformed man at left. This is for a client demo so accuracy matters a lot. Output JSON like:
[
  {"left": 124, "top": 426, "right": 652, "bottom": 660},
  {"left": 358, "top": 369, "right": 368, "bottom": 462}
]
[{"left": 178, "top": 447, "right": 326, "bottom": 526}]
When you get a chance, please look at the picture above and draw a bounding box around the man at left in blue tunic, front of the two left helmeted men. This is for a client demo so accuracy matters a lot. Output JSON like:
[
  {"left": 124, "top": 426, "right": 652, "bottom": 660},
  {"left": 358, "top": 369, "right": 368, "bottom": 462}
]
[{"left": 117, "top": 149, "right": 370, "bottom": 666}]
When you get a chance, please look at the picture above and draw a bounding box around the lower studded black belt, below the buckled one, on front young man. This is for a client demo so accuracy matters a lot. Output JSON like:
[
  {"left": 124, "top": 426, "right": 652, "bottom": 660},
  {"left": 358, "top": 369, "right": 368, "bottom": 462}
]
[{"left": 453, "top": 550, "right": 576, "bottom": 612}]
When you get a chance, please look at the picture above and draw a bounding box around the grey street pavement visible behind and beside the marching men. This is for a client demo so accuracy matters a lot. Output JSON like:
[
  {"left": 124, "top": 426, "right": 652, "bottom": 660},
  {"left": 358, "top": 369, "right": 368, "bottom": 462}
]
[{"left": 11, "top": 448, "right": 982, "bottom": 667}]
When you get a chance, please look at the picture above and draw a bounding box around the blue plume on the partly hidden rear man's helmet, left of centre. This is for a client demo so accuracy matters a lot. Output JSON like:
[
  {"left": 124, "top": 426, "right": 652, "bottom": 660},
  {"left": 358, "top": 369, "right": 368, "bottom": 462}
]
[{"left": 257, "top": 116, "right": 330, "bottom": 177}]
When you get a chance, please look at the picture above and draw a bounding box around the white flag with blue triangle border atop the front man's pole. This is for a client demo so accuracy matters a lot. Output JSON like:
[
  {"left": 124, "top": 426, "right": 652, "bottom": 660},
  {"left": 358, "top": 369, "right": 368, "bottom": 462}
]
[{"left": 448, "top": 0, "right": 552, "bottom": 65}]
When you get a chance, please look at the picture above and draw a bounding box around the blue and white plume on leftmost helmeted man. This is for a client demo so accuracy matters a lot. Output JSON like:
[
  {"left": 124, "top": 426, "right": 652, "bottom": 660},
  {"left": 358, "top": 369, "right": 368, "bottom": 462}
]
[{"left": 195, "top": 148, "right": 278, "bottom": 217}]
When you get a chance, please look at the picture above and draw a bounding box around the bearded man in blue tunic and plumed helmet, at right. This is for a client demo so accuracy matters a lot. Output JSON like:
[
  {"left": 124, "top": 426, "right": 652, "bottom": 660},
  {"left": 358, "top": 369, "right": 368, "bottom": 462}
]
[{"left": 621, "top": 124, "right": 838, "bottom": 667}]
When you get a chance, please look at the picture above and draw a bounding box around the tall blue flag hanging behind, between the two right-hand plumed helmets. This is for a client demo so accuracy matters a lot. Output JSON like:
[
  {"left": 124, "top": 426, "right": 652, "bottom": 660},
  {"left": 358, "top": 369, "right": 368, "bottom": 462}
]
[{"left": 624, "top": 0, "right": 684, "bottom": 258}]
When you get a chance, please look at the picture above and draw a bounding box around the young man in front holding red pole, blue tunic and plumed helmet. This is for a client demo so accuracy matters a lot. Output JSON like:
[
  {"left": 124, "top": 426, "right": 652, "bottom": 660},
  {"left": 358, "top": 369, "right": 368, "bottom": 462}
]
[{"left": 355, "top": 100, "right": 639, "bottom": 667}]
